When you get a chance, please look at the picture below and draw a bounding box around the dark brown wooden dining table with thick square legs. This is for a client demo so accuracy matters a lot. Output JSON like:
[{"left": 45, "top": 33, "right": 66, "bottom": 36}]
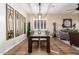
[{"left": 28, "top": 34, "right": 50, "bottom": 53}]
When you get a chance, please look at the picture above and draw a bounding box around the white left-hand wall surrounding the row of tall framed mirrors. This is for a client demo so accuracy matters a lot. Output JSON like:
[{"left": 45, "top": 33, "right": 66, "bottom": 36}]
[{"left": 0, "top": 3, "right": 26, "bottom": 54}]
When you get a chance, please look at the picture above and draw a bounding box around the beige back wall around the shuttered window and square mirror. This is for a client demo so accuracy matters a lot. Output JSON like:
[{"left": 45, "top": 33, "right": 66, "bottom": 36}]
[{"left": 29, "top": 14, "right": 79, "bottom": 33}]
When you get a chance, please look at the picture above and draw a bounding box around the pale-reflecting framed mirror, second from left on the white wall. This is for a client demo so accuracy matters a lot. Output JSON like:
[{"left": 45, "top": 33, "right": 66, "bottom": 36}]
[{"left": 15, "top": 11, "right": 25, "bottom": 36}]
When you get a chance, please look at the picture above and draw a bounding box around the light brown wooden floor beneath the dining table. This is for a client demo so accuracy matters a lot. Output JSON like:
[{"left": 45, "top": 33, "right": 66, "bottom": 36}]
[{"left": 5, "top": 38, "right": 79, "bottom": 55}]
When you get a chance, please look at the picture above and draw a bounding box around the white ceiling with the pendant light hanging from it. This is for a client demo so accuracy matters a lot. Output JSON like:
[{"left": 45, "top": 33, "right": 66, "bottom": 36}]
[{"left": 13, "top": 3, "right": 79, "bottom": 14}]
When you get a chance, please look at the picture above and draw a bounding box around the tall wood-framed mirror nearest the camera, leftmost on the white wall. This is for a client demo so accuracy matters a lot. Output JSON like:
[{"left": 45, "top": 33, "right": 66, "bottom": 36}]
[{"left": 6, "top": 4, "right": 14, "bottom": 39}]
